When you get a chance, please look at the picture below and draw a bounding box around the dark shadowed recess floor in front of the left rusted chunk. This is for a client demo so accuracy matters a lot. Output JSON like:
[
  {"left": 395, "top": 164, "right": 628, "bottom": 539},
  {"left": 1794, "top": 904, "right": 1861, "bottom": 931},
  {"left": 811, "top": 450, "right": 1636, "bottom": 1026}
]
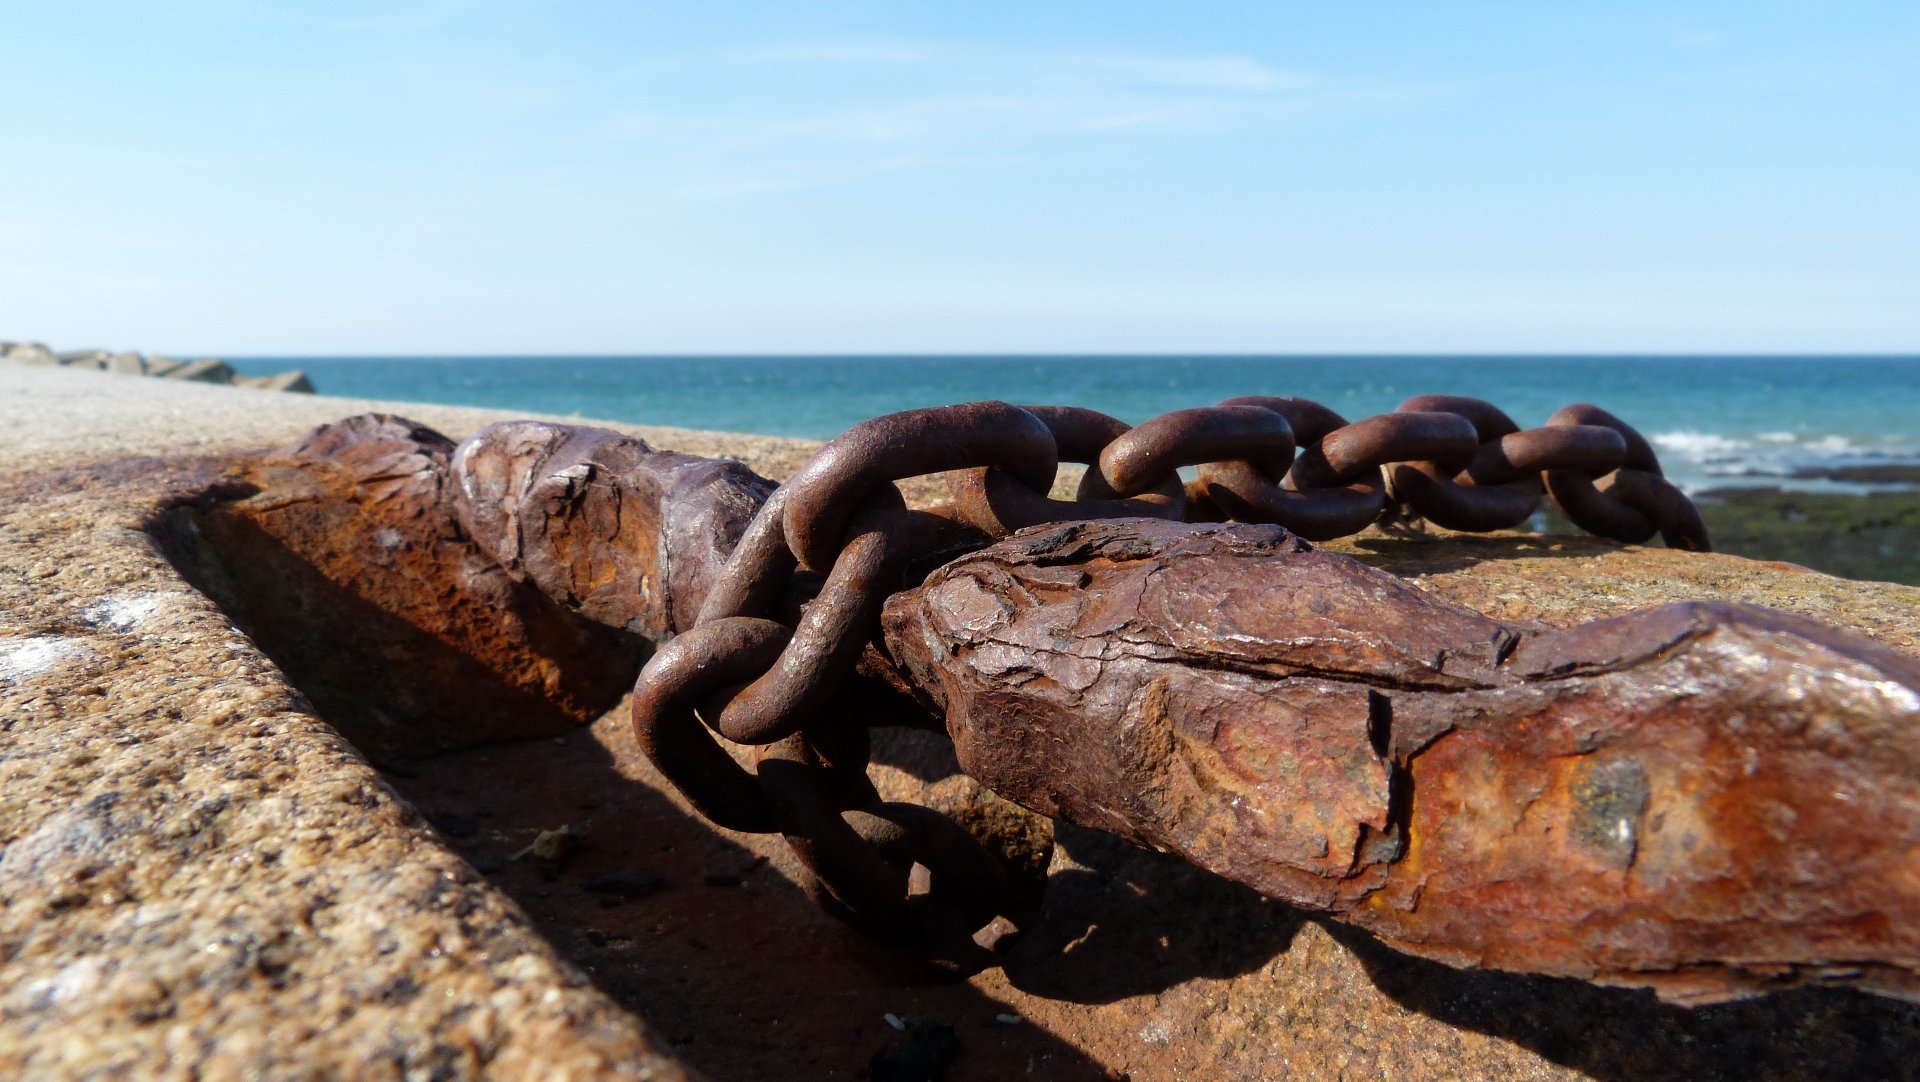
[{"left": 374, "top": 710, "right": 1108, "bottom": 1082}]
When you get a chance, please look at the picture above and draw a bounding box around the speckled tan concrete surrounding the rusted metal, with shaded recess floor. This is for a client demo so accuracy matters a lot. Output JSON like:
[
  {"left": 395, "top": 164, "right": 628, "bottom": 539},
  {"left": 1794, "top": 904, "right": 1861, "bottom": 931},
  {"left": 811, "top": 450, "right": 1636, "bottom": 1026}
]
[{"left": 0, "top": 366, "right": 1920, "bottom": 1082}]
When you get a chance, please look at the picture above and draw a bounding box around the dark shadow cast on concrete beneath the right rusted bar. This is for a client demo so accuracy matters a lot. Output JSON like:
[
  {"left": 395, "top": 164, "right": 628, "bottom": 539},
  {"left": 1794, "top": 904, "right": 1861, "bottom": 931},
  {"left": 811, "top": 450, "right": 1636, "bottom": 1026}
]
[{"left": 1006, "top": 827, "right": 1920, "bottom": 1082}]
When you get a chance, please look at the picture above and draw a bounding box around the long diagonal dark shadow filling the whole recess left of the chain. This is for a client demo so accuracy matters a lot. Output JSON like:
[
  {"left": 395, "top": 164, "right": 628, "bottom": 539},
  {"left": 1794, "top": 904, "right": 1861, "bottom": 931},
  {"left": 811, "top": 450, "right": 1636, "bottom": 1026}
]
[{"left": 150, "top": 485, "right": 1108, "bottom": 1082}]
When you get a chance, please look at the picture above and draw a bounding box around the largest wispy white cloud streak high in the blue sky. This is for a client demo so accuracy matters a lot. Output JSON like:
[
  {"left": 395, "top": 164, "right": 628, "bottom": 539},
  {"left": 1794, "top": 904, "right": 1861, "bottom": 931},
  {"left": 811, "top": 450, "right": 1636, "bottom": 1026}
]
[{"left": 605, "top": 40, "right": 1448, "bottom": 194}]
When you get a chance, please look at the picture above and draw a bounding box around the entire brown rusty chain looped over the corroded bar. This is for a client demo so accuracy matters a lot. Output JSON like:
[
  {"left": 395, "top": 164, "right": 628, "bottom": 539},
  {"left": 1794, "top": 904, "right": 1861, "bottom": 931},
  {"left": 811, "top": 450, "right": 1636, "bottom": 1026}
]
[{"left": 634, "top": 395, "right": 1709, "bottom": 973}]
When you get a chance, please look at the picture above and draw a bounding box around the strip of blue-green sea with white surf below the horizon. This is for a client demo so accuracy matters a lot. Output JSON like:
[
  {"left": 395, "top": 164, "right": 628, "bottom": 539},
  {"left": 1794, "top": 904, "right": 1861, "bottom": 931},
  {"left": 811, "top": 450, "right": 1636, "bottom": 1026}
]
[{"left": 228, "top": 355, "right": 1920, "bottom": 493}]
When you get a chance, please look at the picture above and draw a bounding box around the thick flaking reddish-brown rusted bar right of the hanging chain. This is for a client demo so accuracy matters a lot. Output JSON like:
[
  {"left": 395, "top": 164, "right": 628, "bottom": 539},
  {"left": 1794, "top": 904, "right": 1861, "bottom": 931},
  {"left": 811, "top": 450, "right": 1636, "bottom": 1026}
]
[{"left": 885, "top": 520, "right": 1920, "bottom": 1003}]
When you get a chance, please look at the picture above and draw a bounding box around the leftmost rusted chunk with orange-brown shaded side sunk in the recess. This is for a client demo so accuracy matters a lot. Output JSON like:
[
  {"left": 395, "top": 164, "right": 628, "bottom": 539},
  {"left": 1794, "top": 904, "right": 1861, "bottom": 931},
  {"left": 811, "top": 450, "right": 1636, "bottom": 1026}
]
[{"left": 161, "top": 414, "right": 645, "bottom": 758}]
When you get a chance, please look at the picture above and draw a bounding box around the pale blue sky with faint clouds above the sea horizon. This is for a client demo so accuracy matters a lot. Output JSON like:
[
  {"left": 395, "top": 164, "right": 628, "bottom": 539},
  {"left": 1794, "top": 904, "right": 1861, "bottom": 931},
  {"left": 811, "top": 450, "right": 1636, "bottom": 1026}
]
[{"left": 0, "top": 0, "right": 1920, "bottom": 355}]
